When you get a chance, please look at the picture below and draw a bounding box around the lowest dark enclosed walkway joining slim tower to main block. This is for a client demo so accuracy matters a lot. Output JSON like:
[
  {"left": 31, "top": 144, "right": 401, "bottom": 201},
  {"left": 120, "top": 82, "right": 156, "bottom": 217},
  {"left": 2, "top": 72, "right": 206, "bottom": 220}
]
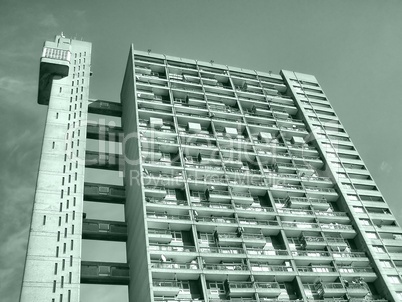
[{"left": 81, "top": 261, "right": 130, "bottom": 285}]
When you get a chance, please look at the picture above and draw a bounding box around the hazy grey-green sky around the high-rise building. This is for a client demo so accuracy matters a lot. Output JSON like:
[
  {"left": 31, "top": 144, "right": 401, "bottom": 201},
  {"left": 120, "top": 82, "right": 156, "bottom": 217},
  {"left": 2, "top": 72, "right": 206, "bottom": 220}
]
[{"left": 0, "top": 0, "right": 402, "bottom": 302}]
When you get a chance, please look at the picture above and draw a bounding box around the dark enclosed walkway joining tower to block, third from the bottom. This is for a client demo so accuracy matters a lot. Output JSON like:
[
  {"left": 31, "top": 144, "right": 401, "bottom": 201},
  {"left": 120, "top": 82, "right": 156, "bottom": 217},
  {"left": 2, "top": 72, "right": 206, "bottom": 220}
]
[{"left": 84, "top": 182, "right": 126, "bottom": 204}]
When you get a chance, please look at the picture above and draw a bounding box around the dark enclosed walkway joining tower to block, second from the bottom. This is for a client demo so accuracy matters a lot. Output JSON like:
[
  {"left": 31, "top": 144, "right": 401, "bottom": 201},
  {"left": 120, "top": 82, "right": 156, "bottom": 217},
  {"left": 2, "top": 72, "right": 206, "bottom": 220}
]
[{"left": 82, "top": 219, "right": 127, "bottom": 241}]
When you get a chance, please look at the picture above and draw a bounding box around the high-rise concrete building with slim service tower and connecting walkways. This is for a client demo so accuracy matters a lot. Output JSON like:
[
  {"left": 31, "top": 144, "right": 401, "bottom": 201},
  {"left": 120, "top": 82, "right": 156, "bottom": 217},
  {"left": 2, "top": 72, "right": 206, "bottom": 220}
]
[{"left": 21, "top": 36, "right": 402, "bottom": 302}]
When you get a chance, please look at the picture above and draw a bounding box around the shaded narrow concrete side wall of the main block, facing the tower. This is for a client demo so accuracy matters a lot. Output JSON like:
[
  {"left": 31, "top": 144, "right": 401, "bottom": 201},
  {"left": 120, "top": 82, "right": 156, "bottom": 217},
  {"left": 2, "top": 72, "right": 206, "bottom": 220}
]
[{"left": 121, "top": 46, "right": 152, "bottom": 302}]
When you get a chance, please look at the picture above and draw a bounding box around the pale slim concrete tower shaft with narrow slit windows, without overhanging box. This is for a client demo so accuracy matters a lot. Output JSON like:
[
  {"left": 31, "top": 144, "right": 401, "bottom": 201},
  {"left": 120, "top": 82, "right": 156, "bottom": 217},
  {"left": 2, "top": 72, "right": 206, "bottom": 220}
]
[{"left": 20, "top": 36, "right": 91, "bottom": 302}]
